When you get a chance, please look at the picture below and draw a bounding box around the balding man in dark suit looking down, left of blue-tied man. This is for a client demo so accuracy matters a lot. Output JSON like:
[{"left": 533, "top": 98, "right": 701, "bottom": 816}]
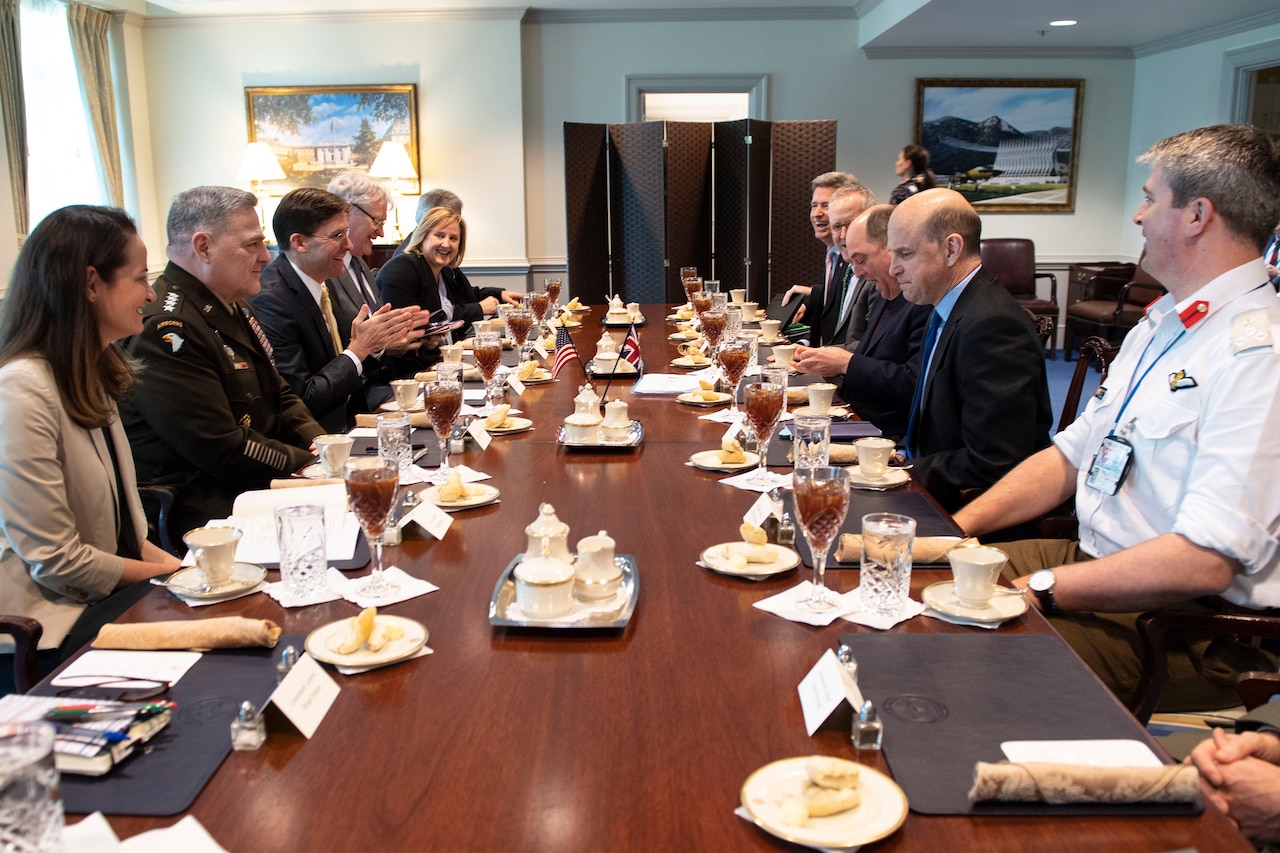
[{"left": 791, "top": 204, "right": 932, "bottom": 441}]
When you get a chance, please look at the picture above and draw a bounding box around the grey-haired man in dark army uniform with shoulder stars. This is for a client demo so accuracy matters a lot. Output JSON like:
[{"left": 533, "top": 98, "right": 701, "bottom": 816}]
[{"left": 120, "top": 187, "right": 324, "bottom": 532}]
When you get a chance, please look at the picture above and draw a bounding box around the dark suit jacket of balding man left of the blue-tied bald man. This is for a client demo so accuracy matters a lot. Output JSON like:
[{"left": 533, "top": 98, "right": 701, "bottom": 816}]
[{"left": 840, "top": 295, "right": 933, "bottom": 442}]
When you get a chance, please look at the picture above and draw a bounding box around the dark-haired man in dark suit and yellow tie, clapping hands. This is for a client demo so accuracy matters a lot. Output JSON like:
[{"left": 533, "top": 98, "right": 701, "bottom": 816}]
[{"left": 252, "top": 187, "right": 417, "bottom": 432}]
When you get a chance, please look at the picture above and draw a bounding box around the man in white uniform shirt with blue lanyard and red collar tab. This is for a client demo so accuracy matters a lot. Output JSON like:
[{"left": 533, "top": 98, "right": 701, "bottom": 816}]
[{"left": 957, "top": 126, "right": 1280, "bottom": 711}]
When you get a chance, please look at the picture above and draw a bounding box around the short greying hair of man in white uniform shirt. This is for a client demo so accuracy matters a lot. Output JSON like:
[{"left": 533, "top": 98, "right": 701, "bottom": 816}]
[{"left": 1138, "top": 124, "right": 1280, "bottom": 251}]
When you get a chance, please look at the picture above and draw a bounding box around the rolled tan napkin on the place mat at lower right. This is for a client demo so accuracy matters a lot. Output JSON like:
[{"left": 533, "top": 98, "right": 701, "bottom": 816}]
[{"left": 969, "top": 761, "right": 1199, "bottom": 806}]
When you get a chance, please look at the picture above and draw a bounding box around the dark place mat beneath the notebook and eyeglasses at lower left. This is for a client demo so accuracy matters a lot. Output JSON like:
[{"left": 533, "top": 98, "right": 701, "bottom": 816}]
[{"left": 43, "top": 635, "right": 291, "bottom": 817}]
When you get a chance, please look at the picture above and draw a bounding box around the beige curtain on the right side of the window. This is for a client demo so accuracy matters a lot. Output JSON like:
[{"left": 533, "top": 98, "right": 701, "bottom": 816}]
[{"left": 65, "top": 0, "right": 124, "bottom": 207}]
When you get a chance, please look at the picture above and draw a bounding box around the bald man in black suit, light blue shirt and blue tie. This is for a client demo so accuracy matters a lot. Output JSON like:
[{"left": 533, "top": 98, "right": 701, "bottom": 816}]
[{"left": 888, "top": 190, "right": 1052, "bottom": 512}]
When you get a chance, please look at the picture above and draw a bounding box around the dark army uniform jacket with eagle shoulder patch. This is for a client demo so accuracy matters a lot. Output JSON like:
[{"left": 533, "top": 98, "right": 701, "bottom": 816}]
[{"left": 120, "top": 263, "right": 324, "bottom": 532}]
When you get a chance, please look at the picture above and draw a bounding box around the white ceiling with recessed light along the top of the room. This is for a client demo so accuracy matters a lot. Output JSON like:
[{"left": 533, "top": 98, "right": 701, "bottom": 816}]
[{"left": 137, "top": 0, "right": 1280, "bottom": 58}]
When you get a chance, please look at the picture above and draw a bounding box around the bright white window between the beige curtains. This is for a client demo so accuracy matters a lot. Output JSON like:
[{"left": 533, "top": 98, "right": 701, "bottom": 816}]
[{"left": 20, "top": 0, "right": 110, "bottom": 228}]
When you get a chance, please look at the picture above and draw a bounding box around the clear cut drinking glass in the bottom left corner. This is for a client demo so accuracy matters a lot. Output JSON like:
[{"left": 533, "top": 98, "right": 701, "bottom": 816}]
[{"left": 0, "top": 722, "right": 63, "bottom": 853}]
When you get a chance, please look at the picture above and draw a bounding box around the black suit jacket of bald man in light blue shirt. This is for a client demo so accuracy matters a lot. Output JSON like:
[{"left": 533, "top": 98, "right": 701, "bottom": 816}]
[{"left": 911, "top": 269, "right": 1052, "bottom": 512}]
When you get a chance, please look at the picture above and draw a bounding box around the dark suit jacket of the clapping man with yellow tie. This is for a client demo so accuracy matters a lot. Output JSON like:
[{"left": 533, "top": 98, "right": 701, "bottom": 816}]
[{"left": 250, "top": 252, "right": 365, "bottom": 433}]
